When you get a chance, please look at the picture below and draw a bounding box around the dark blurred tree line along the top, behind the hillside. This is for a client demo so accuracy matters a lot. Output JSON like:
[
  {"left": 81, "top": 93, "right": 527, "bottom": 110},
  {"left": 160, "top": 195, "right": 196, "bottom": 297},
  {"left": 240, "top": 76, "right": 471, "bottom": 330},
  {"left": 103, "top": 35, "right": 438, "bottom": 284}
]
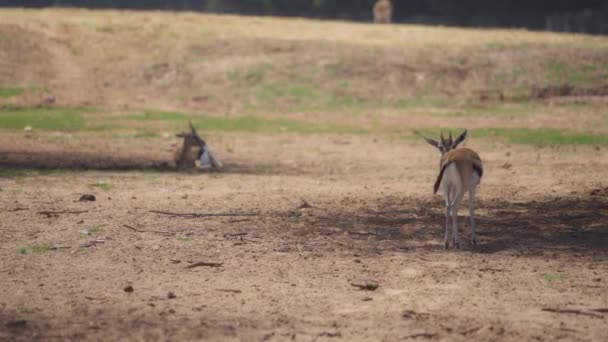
[{"left": 0, "top": 0, "right": 608, "bottom": 34}]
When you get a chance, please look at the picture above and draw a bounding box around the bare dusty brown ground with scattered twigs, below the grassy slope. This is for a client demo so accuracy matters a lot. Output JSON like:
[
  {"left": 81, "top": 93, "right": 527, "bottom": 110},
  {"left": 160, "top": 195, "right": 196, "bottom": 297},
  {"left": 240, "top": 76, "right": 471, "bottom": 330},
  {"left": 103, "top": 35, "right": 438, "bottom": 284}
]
[{"left": 0, "top": 136, "right": 608, "bottom": 341}]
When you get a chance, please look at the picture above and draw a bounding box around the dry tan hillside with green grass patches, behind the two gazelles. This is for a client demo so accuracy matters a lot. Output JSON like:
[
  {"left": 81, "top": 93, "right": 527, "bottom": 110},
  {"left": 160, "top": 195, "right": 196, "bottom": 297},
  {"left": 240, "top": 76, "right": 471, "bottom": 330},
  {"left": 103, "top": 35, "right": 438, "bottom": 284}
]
[{"left": 0, "top": 9, "right": 608, "bottom": 144}]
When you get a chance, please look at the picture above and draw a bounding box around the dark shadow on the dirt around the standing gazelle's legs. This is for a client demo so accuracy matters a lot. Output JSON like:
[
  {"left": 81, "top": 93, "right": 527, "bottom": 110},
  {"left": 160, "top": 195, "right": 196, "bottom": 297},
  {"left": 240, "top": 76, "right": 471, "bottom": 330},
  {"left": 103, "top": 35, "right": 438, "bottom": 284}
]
[{"left": 276, "top": 188, "right": 608, "bottom": 255}]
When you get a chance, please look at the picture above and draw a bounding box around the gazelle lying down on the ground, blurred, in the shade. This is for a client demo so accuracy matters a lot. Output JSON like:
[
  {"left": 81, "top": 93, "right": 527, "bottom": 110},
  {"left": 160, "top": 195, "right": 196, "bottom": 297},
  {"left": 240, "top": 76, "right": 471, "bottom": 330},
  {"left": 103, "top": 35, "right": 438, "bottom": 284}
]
[{"left": 175, "top": 121, "right": 222, "bottom": 171}]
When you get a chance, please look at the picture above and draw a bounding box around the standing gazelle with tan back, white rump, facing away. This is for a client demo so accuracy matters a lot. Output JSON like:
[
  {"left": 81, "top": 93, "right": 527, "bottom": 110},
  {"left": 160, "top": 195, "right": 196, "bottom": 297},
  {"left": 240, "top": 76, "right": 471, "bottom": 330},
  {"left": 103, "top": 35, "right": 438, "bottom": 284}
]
[{"left": 424, "top": 129, "right": 483, "bottom": 249}]
